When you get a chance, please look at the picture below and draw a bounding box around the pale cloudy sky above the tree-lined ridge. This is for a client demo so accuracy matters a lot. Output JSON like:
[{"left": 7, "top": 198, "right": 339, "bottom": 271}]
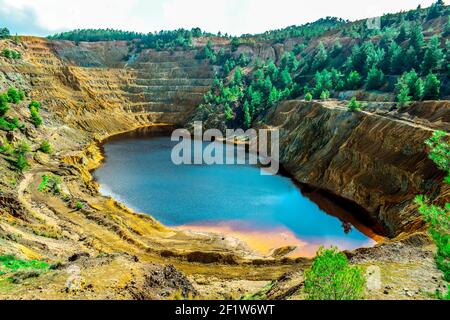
[{"left": 0, "top": 0, "right": 450, "bottom": 36}]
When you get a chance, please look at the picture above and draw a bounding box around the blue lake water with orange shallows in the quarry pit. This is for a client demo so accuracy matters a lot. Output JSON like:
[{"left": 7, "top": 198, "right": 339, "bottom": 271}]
[{"left": 94, "top": 126, "right": 375, "bottom": 256}]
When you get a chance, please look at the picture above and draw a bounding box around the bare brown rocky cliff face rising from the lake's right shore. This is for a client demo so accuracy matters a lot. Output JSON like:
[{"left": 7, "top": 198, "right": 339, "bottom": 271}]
[{"left": 267, "top": 101, "right": 450, "bottom": 237}]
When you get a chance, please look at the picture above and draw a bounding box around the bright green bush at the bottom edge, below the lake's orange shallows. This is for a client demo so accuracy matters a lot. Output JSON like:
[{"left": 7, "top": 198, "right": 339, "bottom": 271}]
[{"left": 305, "top": 248, "right": 365, "bottom": 300}]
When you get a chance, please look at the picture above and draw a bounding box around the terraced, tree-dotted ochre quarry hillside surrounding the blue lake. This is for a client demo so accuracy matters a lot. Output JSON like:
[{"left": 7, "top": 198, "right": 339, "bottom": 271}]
[{"left": 0, "top": 1, "right": 450, "bottom": 299}]
